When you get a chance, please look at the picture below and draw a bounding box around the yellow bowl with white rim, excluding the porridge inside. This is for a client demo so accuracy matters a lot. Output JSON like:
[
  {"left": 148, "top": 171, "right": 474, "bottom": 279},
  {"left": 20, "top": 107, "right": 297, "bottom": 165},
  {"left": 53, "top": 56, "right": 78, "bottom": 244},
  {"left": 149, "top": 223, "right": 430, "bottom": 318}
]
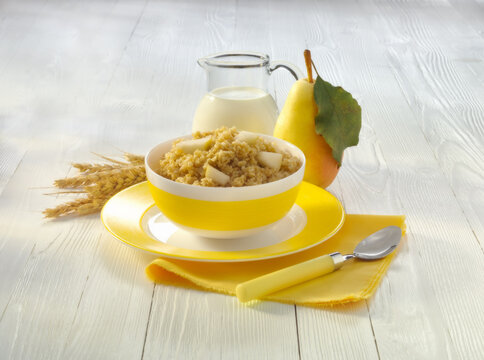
[{"left": 145, "top": 135, "right": 306, "bottom": 238}]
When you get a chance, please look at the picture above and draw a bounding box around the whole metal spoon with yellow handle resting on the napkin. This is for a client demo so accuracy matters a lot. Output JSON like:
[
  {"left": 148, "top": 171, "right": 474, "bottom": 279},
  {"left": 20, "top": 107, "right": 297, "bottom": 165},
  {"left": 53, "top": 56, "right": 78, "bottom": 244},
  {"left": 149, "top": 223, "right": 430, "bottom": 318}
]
[{"left": 235, "top": 226, "right": 402, "bottom": 302}]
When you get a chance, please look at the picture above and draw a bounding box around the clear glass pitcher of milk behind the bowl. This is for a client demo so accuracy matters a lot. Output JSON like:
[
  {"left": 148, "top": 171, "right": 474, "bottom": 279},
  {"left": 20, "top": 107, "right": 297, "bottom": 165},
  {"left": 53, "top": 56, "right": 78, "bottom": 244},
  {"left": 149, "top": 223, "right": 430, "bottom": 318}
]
[{"left": 192, "top": 52, "right": 303, "bottom": 135}]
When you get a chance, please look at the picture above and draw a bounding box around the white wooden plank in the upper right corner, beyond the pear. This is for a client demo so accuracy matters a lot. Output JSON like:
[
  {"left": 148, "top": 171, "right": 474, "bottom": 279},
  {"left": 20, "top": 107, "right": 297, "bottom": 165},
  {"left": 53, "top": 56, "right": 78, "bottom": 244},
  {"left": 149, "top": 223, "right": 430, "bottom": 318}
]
[{"left": 366, "top": 0, "right": 484, "bottom": 253}]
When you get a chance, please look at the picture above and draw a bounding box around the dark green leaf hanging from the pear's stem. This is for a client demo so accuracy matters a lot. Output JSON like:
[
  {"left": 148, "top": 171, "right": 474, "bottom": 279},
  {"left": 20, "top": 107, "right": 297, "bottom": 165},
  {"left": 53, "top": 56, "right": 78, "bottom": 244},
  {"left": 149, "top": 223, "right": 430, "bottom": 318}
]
[{"left": 314, "top": 76, "right": 361, "bottom": 166}]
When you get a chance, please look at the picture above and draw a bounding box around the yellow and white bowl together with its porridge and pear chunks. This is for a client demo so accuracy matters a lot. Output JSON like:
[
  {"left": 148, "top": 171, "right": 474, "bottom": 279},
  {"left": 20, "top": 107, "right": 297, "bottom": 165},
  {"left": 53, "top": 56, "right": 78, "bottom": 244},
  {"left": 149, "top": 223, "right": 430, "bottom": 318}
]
[{"left": 145, "top": 128, "right": 306, "bottom": 238}]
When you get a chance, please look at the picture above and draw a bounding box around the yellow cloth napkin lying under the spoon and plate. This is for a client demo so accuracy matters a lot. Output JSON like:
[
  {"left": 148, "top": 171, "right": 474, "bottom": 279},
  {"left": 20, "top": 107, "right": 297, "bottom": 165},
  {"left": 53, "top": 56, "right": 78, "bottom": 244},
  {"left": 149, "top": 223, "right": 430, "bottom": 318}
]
[{"left": 146, "top": 215, "right": 405, "bottom": 306}]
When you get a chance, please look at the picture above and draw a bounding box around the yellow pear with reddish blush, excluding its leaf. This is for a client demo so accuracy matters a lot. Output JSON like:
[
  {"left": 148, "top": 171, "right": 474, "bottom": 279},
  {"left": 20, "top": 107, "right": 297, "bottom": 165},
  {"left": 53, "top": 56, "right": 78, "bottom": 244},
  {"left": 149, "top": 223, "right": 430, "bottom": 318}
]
[{"left": 274, "top": 79, "right": 339, "bottom": 188}]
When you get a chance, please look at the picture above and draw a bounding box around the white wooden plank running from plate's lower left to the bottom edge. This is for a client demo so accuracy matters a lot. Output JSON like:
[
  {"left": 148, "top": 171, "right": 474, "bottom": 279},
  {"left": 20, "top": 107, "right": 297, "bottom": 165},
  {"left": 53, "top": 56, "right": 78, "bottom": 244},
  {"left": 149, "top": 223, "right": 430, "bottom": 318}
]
[{"left": 61, "top": 235, "right": 154, "bottom": 359}]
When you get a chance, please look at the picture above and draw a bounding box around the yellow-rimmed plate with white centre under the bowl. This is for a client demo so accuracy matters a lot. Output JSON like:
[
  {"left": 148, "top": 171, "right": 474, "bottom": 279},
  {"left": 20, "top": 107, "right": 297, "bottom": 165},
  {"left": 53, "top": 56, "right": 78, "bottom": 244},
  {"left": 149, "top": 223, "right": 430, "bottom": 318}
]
[{"left": 101, "top": 182, "right": 345, "bottom": 262}]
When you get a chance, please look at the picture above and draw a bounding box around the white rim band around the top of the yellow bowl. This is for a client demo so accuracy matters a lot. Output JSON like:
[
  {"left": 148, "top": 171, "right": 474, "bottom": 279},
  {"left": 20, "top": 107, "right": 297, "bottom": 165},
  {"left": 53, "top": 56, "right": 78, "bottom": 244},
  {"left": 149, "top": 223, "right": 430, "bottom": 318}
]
[{"left": 145, "top": 134, "right": 306, "bottom": 201}]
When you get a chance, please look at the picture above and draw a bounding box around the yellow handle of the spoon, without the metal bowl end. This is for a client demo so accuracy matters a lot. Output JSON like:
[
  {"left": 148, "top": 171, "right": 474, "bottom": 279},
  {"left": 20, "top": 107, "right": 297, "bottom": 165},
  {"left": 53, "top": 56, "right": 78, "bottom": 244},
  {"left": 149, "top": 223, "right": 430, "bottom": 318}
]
[{"left": 235, "top": 253, "right": 341, "bottom": 302}]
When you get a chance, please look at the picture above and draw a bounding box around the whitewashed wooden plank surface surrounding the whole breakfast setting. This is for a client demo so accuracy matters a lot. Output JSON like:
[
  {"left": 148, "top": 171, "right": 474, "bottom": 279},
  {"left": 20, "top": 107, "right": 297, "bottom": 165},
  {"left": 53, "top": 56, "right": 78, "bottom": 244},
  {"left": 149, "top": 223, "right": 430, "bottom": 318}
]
[{"left": 0, "top": 0, "right": 484, "bottom": 359}]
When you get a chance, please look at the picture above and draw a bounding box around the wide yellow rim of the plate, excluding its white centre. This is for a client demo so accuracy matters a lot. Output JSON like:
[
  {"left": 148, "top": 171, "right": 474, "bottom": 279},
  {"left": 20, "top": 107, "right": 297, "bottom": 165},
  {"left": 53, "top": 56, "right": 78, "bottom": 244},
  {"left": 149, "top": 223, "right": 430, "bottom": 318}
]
[{"left": 101, "top": 182, "right": 345, "bottom": 261}]
